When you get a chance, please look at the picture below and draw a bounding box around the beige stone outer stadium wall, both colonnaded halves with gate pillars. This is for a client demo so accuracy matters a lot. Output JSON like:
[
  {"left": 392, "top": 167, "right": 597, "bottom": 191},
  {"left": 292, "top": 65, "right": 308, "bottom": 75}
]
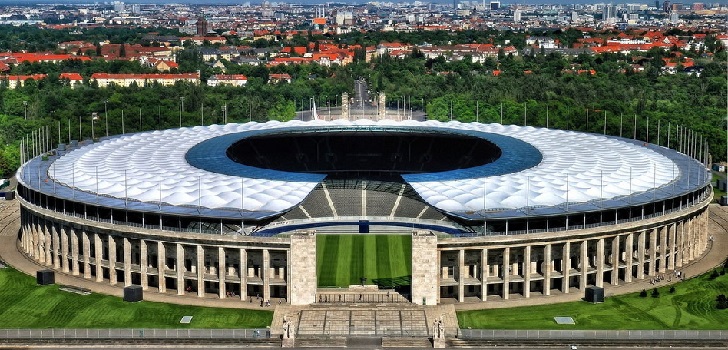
[{"left": 19, "top": 190, "right": 712, "bottom": 304}]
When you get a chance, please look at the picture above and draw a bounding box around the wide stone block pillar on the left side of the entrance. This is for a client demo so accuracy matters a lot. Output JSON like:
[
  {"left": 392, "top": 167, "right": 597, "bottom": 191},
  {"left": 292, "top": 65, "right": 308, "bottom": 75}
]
[{"left": 286, "top": 230, "right": 316, "bottom": 305}]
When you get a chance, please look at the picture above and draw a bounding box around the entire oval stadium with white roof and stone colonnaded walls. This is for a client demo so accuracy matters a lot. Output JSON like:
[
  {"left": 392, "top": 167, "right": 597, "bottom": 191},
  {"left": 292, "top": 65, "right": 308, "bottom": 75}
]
[{"left": 17, "top": 119, "right": 712, "bottom": 305}]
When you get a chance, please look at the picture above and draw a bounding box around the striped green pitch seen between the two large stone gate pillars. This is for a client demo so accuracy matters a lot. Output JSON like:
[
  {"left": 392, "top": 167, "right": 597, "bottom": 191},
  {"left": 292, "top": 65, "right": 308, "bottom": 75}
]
[{"left": 316, "top": 235, "right": 412, "bottom": 287}]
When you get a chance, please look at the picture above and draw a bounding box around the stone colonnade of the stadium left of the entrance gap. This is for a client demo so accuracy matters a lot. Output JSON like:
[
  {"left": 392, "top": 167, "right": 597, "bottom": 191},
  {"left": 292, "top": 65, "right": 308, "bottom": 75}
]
[{"left": 21, "top": 207, "right": 290, "bottom": 302}]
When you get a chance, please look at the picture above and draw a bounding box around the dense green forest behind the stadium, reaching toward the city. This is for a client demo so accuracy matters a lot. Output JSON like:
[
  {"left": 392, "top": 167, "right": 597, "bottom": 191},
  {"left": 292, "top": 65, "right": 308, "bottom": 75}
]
[{"left": 0, "top": 26, "right": 728, "bottom": 177}]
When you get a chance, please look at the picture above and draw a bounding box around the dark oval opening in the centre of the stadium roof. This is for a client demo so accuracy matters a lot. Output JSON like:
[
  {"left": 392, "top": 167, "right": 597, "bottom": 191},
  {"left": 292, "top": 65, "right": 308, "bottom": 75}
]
[{"left": 226, "top": 132, "right": 502, "bottom": 178}]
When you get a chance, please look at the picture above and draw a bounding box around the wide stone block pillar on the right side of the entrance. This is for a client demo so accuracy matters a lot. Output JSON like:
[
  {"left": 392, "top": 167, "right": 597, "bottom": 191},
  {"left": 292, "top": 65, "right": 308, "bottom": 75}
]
[{"left": 412, "top": 231, "right": 440, "bottom": 305}]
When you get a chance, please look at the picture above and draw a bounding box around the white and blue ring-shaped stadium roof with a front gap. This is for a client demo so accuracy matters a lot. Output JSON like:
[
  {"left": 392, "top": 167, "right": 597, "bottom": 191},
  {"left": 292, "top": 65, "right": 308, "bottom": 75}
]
[{"left": 19, "top": 120, "right": 709, "bottom": 219}]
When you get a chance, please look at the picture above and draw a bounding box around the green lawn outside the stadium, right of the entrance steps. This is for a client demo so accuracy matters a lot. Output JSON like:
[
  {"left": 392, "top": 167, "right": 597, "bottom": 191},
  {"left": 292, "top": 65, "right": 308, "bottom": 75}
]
[{"left": 457, "top": 274, "right": 728, "bottom": 330}]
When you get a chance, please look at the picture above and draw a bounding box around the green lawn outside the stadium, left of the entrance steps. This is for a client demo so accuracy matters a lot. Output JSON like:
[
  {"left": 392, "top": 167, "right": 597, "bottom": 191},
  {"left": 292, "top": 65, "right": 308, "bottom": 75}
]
[{"left": 0, "top": 268, "right": 273, "bottom": 328}]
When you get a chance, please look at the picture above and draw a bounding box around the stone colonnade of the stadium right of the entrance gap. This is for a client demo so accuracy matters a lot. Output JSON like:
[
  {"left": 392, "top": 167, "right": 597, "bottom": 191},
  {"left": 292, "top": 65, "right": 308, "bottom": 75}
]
[{"left": 436, "top": 206, "right": 709, "bottom": 302}]
